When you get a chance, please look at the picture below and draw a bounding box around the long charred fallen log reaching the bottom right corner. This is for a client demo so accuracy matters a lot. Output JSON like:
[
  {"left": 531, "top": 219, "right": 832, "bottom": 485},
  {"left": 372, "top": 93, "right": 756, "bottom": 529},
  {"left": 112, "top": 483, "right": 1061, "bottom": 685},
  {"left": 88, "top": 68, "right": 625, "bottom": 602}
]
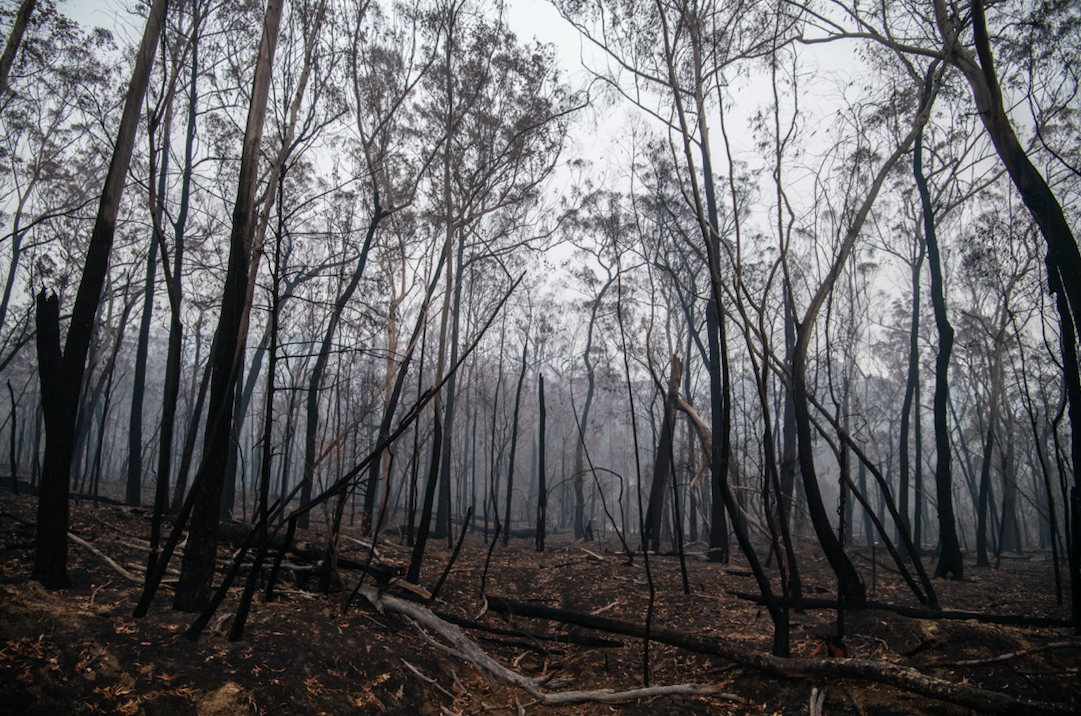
[{"left": 485, "top": 595, "right": 1081, "bottom": 716}]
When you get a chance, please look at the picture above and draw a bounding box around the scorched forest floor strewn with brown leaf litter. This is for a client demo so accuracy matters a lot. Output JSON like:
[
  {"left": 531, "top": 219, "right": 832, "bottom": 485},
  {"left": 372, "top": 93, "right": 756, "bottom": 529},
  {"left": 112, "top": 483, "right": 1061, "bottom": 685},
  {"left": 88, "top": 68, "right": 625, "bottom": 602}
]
[{"left": 0, "top": 491, "right": 1081, "bottom": 716}]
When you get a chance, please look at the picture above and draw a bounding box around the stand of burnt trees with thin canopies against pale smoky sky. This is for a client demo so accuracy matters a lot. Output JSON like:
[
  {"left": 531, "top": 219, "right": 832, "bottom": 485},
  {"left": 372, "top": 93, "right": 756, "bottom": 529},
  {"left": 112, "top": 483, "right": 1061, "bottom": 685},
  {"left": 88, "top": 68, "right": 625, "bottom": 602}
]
[{"left": 0, "top": 0, "right": 1081, "bottom": 653}]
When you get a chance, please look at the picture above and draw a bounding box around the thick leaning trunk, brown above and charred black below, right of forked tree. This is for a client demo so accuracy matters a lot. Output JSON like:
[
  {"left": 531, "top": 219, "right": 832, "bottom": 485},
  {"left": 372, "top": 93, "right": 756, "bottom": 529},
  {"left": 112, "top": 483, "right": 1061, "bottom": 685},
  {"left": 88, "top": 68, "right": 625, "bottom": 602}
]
[{"left": 172, "top": 0, "right": 284, "bottom": 611}]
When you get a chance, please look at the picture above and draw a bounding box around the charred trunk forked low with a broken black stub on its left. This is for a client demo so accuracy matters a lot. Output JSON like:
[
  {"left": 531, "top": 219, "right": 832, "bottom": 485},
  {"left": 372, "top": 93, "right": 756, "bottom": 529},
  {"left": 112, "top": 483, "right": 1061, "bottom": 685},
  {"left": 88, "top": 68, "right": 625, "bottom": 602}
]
[{"left": 32, "top": 0, "right": 169, "bottom": 589}]
